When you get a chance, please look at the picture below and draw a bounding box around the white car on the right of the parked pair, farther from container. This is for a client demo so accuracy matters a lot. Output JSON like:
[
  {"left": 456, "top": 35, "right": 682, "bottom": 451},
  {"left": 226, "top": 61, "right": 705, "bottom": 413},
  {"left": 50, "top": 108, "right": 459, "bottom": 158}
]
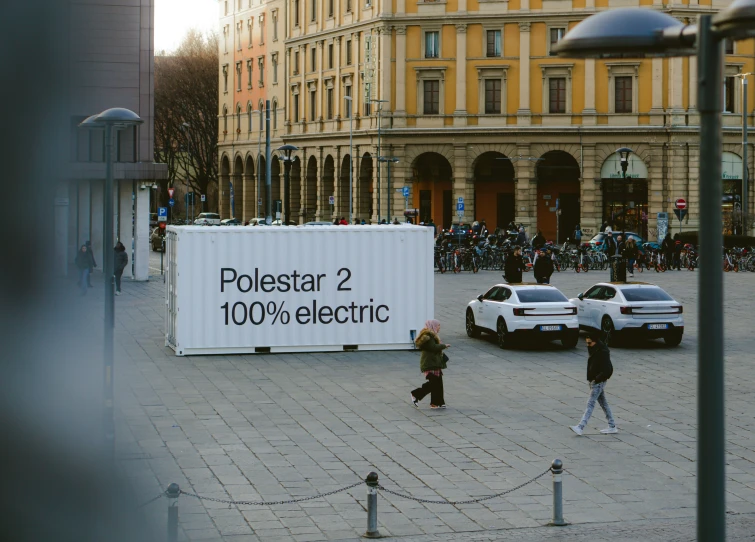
[{"left": 570, "top": 282, "right": 684, "bottom": 346}]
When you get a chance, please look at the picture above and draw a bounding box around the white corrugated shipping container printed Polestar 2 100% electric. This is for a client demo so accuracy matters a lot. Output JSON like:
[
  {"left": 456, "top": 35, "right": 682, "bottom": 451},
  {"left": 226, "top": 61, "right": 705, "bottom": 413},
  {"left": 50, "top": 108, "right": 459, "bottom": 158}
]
[{"left": 166, "top": 225, "right": 434, "bottom": 355}]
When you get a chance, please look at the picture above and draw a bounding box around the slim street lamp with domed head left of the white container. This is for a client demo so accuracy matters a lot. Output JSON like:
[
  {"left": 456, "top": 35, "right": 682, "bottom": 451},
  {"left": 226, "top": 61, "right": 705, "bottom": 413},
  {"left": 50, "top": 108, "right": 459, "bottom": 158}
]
[{"left": 79, "top": 107, "right": 144, "bottom": 459}]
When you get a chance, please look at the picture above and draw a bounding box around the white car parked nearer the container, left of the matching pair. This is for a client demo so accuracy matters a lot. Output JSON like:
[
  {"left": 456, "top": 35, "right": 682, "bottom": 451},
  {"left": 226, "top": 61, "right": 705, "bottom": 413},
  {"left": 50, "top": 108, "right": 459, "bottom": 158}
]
[{"left": 466, "top": 284, "right": 579, "bottom": 348}]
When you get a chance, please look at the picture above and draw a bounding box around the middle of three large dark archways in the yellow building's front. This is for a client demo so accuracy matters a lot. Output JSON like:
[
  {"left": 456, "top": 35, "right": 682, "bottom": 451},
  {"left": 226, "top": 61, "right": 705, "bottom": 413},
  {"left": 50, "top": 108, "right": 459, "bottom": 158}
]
[{"left": 472, "top": 151, "right": 516, "bottom": 232}]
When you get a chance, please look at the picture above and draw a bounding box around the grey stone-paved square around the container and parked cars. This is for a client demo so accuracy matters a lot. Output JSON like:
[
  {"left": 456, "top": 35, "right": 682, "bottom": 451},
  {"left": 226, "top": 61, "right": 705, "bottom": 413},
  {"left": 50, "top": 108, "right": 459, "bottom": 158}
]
[{"left": 121, "top": 255, "right": 755, "bottom": 542}]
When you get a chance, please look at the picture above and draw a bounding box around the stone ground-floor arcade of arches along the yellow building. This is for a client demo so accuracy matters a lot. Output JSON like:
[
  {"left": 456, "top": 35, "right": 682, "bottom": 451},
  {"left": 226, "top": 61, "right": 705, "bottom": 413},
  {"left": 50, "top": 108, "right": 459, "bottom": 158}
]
[{"left": 219, "top": 128, "right": 753, "bottom": 242}]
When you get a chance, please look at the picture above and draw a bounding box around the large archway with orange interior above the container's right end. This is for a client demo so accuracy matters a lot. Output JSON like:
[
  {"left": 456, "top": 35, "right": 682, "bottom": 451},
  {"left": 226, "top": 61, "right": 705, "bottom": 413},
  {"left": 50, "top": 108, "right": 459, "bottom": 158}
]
[{"left": 412, "top": 152, "right": 454, "bottom": 229}]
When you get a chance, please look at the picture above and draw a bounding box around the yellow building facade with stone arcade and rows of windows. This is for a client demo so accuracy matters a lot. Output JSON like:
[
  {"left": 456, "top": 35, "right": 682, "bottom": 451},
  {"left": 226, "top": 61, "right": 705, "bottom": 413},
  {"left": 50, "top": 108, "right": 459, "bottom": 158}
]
[{"left": 219, "top": 0, "right": 755, "bottom": 242}]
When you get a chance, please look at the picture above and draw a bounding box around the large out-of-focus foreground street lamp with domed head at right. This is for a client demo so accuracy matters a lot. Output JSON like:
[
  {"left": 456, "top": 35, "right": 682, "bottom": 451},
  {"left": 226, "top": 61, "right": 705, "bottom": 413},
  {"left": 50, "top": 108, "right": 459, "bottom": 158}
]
[{"left": 551, "top": 0, "right": 755, "bottom": 542}]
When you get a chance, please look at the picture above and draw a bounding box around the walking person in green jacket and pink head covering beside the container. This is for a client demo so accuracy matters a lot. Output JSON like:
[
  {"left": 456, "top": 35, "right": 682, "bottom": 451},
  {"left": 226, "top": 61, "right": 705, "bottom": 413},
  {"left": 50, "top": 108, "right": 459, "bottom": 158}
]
[{"left": 411, "top": 320, "right": 451, "bottom": 409}]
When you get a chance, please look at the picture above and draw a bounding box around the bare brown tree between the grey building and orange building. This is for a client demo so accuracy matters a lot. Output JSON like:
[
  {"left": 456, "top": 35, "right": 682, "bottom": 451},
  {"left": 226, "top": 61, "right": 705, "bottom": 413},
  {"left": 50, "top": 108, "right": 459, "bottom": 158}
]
[{"left": 155, "top": 30, "right": 218, "bottom": 210}]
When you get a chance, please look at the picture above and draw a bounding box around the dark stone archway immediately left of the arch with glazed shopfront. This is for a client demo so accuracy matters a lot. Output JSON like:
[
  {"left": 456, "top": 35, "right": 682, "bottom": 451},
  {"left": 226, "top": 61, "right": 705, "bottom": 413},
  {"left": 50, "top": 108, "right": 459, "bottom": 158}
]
[{"left": 533, "top": 150, "right": 581, "bottom": 243}]
